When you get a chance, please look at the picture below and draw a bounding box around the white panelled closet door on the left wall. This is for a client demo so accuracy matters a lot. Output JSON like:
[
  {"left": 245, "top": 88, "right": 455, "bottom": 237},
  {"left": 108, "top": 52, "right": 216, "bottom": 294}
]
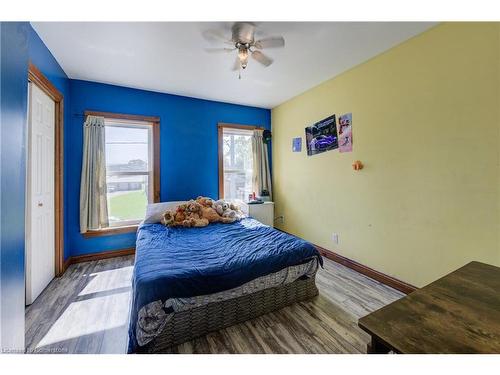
[{"left": 26, "top": 83, "right": 55, "bottom": 305}]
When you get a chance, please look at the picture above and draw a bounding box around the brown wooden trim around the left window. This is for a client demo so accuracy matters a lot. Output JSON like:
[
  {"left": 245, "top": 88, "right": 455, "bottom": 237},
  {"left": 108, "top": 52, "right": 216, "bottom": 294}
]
[{"left": 82, "top": 110, "right": 160, "bottom": 238}]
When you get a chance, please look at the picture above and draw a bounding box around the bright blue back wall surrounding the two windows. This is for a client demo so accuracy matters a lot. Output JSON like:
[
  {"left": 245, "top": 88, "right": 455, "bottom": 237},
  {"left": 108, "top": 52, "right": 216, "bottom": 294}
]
[{"left": 65, "top": 80, "right": 271, "bottom": 255}]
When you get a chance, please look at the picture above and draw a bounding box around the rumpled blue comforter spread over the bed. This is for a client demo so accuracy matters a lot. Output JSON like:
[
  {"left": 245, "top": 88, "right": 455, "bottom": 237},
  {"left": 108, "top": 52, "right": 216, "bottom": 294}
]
[{"left": 129, "top": 218, "right": 322, "bottom": 352}]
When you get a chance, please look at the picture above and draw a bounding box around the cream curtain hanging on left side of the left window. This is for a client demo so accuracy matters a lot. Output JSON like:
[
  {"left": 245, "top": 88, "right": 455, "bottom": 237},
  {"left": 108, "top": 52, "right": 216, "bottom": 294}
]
[{"left": 80, "top": 116, "right": 109, "bottom": 233}]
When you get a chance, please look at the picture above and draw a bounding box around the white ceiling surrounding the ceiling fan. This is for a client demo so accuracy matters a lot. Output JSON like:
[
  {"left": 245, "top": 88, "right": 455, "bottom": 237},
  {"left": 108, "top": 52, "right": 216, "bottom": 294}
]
[{"left": 32, "top": 22, "right": 435, "bottom": 108}]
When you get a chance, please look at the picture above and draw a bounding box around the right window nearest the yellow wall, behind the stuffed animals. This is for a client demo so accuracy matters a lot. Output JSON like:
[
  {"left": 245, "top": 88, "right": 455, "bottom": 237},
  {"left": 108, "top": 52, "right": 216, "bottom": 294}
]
[{"left": 219, "top": 124, "right": 255, "bottom": 201}]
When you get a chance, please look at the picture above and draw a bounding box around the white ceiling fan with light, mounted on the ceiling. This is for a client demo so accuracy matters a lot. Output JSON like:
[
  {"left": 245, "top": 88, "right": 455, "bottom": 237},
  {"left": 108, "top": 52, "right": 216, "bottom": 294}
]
[{"left": 203, "top": 22, "right": 285, "bottom": 79}]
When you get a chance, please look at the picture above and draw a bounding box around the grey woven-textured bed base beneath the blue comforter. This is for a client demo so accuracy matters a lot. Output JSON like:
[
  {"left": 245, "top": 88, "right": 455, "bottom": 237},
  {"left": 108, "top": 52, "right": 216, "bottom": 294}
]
[{"left": 137, "top": 274, "right": 318, "bottom": 353}]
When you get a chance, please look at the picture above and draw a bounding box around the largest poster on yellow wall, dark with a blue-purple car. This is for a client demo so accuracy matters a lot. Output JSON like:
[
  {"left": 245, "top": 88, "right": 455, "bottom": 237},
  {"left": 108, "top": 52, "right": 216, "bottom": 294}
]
[{"left": 306, "top": 115, "right": 338, "bottom": 156}]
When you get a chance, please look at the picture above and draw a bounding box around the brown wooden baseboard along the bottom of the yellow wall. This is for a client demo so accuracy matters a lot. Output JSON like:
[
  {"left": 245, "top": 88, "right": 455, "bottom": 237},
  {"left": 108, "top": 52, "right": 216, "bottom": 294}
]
[{"left": 314, "top": 245, "right": 418, "bottom": 294}]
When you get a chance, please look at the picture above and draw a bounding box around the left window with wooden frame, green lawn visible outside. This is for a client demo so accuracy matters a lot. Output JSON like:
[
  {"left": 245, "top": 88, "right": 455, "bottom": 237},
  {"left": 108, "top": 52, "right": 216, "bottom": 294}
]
[{"left": 86, "top": 112, "right": 159, "bottom": 236}]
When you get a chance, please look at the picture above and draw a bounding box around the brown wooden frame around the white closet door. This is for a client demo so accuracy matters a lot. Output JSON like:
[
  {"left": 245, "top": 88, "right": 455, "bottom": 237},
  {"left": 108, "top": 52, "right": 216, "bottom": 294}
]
[{"left": 28, "top": 62, "right": 65, "bottom": 277}]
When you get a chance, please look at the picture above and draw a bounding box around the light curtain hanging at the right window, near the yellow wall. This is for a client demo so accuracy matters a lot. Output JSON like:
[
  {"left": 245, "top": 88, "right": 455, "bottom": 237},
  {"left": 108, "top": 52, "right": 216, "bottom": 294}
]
[{"left": 252, "top": 129, "right": 272, "bottom": 200}]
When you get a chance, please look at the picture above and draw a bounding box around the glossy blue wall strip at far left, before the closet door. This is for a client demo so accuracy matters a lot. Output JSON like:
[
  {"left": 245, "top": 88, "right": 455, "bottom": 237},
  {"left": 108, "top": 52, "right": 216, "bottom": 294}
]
[{"left": 0, "top": 22, "right": 29, "bottom": 351}]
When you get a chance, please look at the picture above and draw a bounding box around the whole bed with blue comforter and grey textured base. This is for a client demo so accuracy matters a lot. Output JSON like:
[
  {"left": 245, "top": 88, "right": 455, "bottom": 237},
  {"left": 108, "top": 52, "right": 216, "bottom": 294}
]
[{"left": 128, "top": 218, "right": 322, "bottom": 353}]
